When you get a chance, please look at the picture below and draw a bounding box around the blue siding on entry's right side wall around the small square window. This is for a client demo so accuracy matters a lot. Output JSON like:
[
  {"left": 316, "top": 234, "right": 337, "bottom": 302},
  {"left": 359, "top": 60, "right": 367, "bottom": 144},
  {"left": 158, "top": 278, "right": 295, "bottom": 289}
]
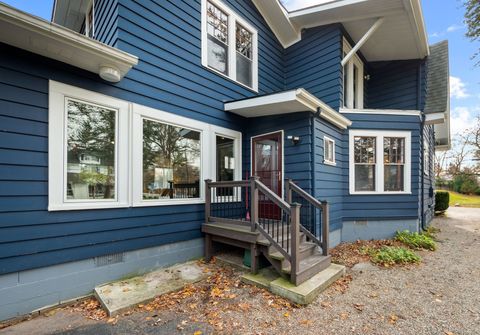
[{"left": 312, "top": 116, "right": 348, "bottom": 231}]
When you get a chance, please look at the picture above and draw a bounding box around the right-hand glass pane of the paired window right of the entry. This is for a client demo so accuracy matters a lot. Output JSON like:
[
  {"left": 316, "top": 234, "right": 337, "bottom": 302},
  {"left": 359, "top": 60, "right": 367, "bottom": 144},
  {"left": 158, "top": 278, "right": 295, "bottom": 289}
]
[{"left": 383, "top": 137, "right": 405, "bottom": 191}]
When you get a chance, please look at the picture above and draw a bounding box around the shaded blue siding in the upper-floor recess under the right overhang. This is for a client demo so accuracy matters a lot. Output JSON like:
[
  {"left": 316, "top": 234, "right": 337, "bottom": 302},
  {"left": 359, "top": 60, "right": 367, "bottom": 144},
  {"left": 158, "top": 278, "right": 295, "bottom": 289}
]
[{"left": 365, "top": 60, "right": 425, "bottom": 110}]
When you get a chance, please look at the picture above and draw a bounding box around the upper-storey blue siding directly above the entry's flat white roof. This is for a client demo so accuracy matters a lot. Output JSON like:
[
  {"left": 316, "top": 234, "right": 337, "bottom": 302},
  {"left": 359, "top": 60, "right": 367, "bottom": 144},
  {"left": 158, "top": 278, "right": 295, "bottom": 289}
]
[{"left": 285, "top": 25, "right": 343, "bottom": 110}]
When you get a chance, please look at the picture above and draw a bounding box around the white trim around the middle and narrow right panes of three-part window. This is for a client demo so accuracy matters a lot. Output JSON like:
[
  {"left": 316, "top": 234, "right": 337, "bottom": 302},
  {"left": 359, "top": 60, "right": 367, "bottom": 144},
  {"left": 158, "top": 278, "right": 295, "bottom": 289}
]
[{"left": 132, "top": 104, "right": 242, "bottom": 207}]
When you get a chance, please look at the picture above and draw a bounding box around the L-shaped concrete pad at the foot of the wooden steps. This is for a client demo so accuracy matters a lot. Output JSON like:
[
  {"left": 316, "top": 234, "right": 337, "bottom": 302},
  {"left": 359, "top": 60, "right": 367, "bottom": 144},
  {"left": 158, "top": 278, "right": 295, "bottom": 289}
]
[{"left": 242, "top": 264, "right": 345, "bottom": 305}]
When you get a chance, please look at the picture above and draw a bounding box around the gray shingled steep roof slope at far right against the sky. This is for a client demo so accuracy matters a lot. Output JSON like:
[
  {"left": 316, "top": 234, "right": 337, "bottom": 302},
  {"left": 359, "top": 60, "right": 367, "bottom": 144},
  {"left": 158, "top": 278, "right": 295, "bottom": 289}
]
[{"left": 425, "top": 41, "right": 450, "bottom": 114}]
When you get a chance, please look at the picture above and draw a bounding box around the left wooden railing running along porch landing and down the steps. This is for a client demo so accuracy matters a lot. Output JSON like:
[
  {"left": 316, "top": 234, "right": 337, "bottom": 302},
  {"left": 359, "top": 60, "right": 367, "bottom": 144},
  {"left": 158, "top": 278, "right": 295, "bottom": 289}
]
[{"left": 205, "top": 176, "right": 301, "bottom": 282}]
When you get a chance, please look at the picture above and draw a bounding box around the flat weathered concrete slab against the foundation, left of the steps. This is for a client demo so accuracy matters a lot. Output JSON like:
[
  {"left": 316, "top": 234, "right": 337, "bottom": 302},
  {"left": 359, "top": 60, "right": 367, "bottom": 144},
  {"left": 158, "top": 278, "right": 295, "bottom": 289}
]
[{"left": 94, "top": 261, "right": 210, "bottom": 316}]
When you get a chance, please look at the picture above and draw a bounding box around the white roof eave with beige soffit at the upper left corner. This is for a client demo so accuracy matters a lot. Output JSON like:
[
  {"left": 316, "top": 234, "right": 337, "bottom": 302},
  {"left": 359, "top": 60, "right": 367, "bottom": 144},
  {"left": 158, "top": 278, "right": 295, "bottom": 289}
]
[{"left": 0, "top": 3, "right": 138, "bottom": 78}]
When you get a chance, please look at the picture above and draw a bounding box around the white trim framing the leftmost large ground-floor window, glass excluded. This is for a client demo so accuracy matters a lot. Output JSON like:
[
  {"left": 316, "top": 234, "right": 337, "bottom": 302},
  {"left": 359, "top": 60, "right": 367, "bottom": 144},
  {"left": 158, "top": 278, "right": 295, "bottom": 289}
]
[{"left": 48, "top": 81, "right": 130, "bottom": 211}]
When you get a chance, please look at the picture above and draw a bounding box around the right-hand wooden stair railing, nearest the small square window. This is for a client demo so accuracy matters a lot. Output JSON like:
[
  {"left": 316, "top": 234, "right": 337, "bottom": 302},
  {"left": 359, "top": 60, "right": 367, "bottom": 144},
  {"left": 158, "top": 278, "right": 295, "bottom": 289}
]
[{"left": 285, "top": 179, "right": 329, "bottom": 256}]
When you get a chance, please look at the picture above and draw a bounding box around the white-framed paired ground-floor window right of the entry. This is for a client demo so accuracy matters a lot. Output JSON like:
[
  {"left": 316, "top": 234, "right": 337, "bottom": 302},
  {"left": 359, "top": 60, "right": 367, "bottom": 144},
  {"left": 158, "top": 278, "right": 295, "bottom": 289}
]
[{"left": 349, "top": 130, "right": 411, "bottom": 194}]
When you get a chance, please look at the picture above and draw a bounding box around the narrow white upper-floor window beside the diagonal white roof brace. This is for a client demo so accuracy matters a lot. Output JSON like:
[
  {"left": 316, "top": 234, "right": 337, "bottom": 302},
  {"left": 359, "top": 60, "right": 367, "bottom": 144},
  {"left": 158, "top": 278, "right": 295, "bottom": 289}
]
[{"left": 342, "top": 39, "right": 364, "bottom": 109}]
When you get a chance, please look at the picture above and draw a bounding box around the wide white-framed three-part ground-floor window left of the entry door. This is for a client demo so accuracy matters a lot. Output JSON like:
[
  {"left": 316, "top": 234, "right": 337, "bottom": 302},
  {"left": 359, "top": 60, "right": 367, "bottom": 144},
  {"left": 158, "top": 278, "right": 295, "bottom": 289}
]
[{"left": 48, "top": 81, "right": 242, "bottom": 211}]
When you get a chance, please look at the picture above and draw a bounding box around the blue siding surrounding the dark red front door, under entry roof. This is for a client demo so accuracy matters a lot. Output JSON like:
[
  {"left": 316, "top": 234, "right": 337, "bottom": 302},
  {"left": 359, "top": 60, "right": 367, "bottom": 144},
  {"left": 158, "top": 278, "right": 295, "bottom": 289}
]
[{"left": 243, "top": 112, "right": 312, "bottom": 193}]
